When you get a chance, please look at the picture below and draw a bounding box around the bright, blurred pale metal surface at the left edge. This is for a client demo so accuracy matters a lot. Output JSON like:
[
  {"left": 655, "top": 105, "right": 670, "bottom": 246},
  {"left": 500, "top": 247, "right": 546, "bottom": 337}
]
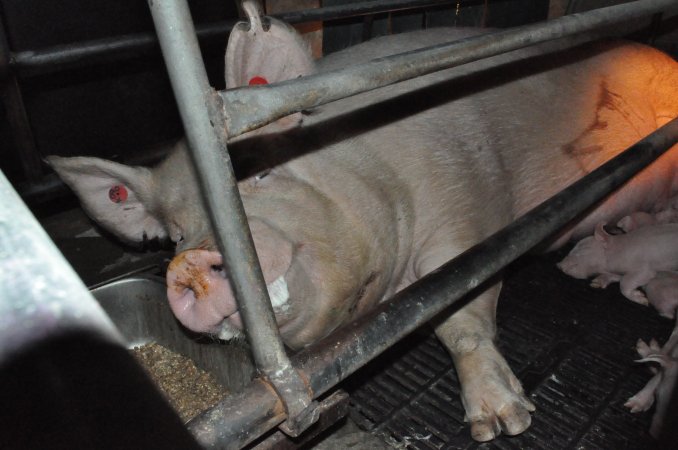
[{"left": 0, "top": 167, "right": 122, "bottom": 363}]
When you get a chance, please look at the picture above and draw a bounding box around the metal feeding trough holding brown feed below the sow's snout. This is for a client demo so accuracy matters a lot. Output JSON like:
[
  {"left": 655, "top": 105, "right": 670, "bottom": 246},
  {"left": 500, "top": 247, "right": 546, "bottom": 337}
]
[{"left": 92, "top": 275, "right": 254, "bottom": 392}]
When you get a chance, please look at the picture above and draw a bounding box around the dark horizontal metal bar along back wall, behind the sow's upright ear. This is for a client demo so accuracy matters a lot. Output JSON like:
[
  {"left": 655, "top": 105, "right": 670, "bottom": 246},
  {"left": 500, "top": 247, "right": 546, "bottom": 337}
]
[{"left": 10, "top": 0, "right": 449, "bottom": 77}]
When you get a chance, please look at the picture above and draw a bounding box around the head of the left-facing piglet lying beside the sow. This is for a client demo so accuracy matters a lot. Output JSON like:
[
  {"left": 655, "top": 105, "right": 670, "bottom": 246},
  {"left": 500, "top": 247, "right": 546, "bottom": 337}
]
[{"left": 558, "top": 223, "right": 612, "bottom": 279}]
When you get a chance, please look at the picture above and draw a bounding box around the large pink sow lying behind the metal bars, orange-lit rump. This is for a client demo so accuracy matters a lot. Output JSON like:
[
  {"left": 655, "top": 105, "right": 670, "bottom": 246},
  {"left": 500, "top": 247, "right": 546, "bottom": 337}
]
[{"left": 49, "top": 22, "right": 678, "bottom": 441}]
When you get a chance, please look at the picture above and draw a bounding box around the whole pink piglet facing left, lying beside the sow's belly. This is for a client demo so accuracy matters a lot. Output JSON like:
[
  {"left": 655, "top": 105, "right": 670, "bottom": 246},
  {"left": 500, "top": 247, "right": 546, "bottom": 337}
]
[{"left": 558, "top": 222, "right": 678, "bottom": 305}]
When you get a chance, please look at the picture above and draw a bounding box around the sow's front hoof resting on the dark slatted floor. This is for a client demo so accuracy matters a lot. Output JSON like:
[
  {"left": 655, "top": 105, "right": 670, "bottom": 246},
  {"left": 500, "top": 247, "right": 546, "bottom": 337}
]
[{"left": 456, "top": 349, "right": 535, "bottom": 442}]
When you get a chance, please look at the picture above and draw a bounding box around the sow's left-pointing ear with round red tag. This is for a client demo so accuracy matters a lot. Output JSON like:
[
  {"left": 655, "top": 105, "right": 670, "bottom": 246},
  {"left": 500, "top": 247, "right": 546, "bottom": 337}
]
[{"left": 46, "top": 156, "right": 167, "bottom": 242}]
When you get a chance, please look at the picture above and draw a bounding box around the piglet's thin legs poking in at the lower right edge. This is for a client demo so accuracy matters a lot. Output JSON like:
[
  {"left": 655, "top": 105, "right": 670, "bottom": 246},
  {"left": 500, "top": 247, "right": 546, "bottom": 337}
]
[{"left": 624, "top": 324, "right": 678, "bottom": 438}]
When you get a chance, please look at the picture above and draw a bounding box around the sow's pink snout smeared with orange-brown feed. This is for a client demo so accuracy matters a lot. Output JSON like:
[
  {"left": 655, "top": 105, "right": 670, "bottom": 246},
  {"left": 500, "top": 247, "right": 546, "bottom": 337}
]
[{"left": 167, "top": 249, "right": 241, "bottom": 333}]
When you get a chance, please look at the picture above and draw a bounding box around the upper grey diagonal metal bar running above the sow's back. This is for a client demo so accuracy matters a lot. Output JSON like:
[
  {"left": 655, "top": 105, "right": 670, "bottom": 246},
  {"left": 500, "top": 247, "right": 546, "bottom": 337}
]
[{"left": 219, "top": 0, "right": 678, "bottom": 137}]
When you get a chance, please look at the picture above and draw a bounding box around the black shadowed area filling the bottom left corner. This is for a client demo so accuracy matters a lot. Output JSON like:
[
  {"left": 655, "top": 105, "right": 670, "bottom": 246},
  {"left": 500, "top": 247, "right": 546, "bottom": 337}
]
[{"left": 0, "top": 331, "right": 200, "bottom": 450}]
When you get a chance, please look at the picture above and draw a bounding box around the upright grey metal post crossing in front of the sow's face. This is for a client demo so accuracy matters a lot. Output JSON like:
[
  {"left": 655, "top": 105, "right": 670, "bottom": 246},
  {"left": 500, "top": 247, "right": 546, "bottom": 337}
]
[{"left": 148, "top": 0, "right": 317, "bottom": 436}]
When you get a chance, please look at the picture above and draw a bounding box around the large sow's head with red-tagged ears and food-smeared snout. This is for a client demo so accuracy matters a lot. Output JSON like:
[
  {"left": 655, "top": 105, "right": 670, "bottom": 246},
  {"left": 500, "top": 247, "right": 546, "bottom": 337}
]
[{"left": 47, "top": 16, "right": 388, "bottom": 348}]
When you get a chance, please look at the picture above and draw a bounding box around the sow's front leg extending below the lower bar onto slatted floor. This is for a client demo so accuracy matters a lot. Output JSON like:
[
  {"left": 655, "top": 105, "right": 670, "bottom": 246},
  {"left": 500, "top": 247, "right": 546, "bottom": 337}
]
[{"left": 435, "top": 282, "right": 535, "bottom": 441}]
